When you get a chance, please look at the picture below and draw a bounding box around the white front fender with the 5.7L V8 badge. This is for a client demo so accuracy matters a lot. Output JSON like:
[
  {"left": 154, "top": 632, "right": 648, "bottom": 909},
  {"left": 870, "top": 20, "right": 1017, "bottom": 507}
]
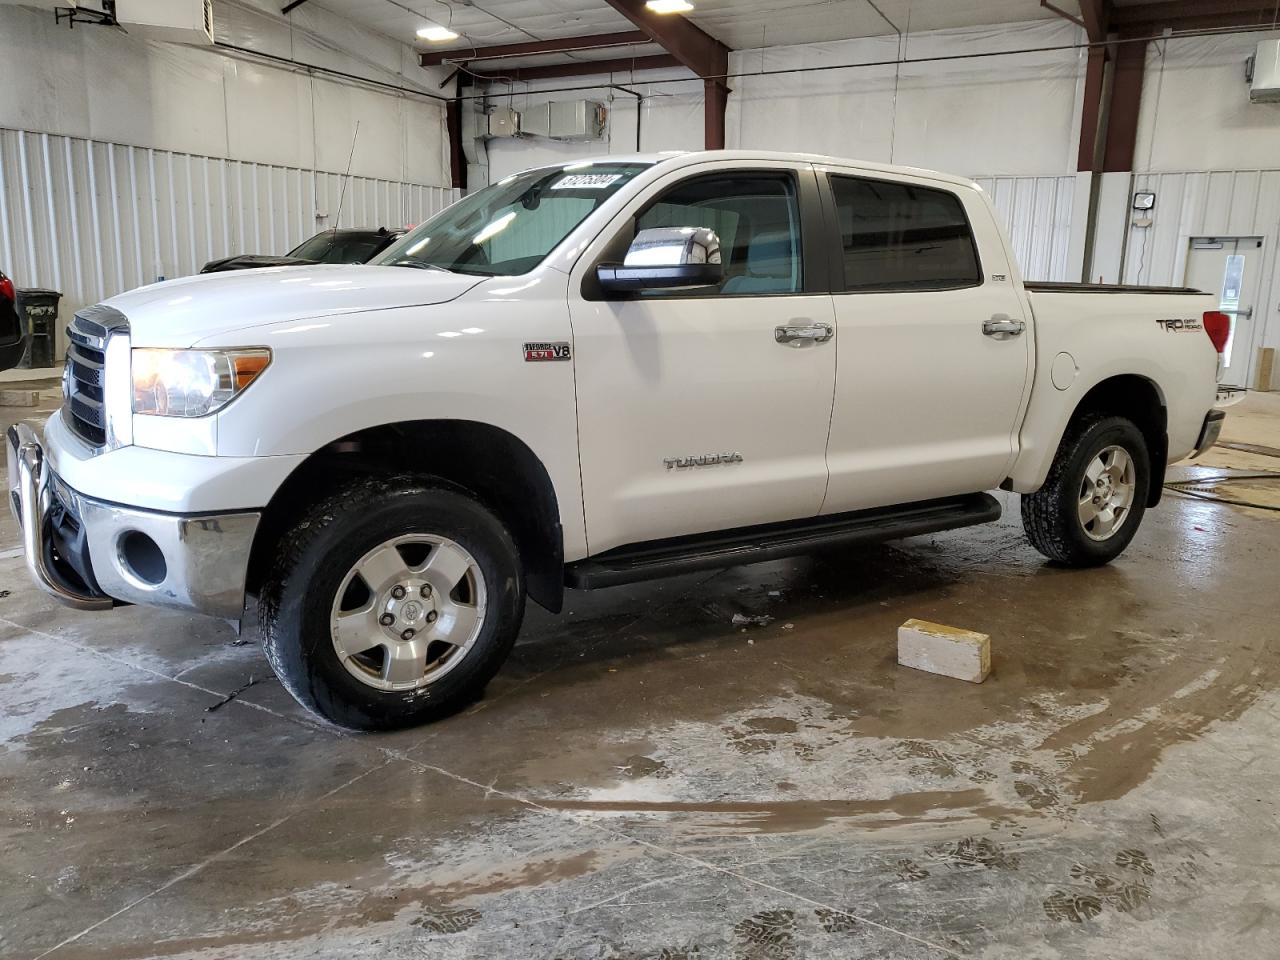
[{"left": 202, "top": 284, "right": 586, "bottom": 568}]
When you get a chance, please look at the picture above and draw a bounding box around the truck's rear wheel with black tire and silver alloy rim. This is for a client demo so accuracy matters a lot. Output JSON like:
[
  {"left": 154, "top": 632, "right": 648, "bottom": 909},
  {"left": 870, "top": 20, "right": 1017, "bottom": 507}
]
[{"left": 1021, "top": 415, "right": 1151, "bottom": 567}]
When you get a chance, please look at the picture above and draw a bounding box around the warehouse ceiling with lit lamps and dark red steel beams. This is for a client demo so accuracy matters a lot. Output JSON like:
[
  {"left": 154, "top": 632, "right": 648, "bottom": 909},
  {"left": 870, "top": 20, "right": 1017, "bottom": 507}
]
[{"left": 299, "top": 0, "right": 1280, "bottom": 81}]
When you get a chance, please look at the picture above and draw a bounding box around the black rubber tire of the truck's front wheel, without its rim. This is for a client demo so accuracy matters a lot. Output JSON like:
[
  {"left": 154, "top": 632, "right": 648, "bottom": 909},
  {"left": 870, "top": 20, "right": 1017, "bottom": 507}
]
[{"left": 259, "top": 476, "right": 525, "bottom": 730}]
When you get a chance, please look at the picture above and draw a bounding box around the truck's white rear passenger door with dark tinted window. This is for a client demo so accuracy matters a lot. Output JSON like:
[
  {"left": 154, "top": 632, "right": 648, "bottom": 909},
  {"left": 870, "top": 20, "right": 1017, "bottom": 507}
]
[{"left": 819, "top": 168, "right": 1033, "bottom": 513}]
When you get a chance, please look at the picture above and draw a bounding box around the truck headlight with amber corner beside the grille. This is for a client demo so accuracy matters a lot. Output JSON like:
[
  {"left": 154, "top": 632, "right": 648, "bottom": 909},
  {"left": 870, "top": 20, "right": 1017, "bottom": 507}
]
[{"left": 133, "top": 347, "right": 271, "bottom": 417}]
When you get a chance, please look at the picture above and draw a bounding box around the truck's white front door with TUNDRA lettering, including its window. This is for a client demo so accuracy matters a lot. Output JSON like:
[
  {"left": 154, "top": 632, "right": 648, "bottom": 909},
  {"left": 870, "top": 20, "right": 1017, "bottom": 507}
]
[{"left": 570, "top": 163, "right": 836, "bottom": 554}]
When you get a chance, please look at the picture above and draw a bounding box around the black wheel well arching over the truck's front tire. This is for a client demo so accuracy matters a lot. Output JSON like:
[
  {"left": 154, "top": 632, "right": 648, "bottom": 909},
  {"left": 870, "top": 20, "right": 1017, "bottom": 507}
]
[{"left": 247, "top": 420, "right": 564, "bottom": 613}]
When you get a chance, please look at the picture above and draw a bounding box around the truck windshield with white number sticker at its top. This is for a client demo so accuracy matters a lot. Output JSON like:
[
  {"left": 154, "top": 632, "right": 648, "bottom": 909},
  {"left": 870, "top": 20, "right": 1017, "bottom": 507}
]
[{"left": 376, "top": 163, "right": 649, "bottom": 276}]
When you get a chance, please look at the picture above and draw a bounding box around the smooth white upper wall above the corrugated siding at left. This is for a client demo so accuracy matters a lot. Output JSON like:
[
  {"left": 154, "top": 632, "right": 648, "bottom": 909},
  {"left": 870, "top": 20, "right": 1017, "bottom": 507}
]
[{"left": 0, "top": 3, "right": 449, "bottom": 186}]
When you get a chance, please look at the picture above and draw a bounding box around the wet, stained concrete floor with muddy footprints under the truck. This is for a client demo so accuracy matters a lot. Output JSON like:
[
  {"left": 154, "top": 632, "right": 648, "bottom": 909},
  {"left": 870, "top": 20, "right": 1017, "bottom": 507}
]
[{"left": 0, "top": 394, "right": 1280, "bottom": 960}]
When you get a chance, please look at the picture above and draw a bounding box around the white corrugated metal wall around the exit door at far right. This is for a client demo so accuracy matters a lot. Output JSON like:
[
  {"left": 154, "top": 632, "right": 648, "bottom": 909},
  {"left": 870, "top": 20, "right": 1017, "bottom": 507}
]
[{"left": 1124, "top": 170, "right": 1280, "bottom": 378}]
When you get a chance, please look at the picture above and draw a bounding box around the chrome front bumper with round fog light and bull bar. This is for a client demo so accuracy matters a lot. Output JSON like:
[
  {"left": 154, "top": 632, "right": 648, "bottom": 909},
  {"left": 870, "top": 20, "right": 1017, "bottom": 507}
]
[{"left": 5, "top": 424, "right": 261, "bottom": 621}]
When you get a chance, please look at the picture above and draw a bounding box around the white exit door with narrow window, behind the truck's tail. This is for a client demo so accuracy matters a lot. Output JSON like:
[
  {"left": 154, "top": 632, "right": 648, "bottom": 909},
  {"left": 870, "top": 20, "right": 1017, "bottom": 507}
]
[{"left": 1185, "top": 237, "right": 1262, "bottom": 387}]
